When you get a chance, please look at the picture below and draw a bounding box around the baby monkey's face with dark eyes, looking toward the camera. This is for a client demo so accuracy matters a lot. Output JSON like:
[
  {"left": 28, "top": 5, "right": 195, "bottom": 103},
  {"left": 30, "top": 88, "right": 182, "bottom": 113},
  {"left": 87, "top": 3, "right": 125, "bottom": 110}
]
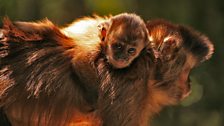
[{"left": 106, "top": 27, "right": 148, "bottom": 69}]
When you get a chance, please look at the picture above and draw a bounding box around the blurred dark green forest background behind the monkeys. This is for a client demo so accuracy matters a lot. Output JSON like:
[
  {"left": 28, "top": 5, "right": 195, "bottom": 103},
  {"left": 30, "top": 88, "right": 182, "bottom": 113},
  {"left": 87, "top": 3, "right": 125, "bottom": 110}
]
[{"left": 0, "top": 0, "right": 224, "bottom": 126}]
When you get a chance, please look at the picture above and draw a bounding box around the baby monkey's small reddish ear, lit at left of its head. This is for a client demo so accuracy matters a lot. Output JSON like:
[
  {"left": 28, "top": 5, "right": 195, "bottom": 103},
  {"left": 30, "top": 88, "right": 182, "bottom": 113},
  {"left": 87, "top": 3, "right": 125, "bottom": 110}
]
[{"left": 98, "top": 22, "right": 110, "bottom": 41}]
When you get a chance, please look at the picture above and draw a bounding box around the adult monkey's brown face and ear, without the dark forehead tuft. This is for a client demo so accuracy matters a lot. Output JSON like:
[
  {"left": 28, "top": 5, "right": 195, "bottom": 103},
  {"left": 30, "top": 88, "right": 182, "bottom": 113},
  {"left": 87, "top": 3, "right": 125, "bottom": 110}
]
[{"left": 148, "top": 22, "right": 192, "bottom": 101}]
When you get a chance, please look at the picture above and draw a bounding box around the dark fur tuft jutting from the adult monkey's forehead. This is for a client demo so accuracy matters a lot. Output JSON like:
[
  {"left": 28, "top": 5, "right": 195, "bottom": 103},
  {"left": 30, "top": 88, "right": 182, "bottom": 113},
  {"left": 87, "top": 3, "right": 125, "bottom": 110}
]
[{"left": 178, "top": 25, "right": 214, "bottom": 63}]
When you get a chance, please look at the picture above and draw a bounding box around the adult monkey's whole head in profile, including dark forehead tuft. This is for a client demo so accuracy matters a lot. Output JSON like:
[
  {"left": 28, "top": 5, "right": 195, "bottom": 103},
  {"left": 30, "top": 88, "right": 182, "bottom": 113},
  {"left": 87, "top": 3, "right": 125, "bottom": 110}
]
[{"left": 147, "top": 20, "right": 213, "bottom": 101}]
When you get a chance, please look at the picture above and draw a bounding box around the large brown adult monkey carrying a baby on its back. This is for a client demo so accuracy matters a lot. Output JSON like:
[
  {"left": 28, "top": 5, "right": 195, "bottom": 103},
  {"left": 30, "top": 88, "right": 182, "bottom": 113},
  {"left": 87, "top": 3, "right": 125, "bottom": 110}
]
[{"left": 0, "top": 17, "right": 213, "bottom": 126}]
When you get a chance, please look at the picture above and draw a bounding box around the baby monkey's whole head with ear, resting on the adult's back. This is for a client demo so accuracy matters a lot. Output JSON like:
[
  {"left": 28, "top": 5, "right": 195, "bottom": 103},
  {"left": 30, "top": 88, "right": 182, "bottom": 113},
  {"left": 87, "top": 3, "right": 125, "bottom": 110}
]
[{"left": 99, "top": 13, "right": 149, "bottom": 69}]
